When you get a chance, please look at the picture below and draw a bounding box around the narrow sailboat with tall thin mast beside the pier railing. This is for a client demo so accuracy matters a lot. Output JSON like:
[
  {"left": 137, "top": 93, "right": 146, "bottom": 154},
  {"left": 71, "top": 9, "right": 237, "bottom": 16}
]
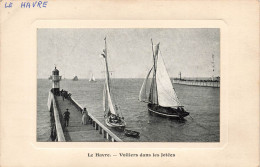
[{"left": 101, "top": 38, "right": 126, "bottom": 130}]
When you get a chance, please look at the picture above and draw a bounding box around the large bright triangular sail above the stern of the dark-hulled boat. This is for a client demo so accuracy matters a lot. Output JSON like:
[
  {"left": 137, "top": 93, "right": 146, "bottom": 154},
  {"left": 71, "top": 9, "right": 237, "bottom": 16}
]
[{"left": 156, "top": 49, "right": 181, "bottom": 107}]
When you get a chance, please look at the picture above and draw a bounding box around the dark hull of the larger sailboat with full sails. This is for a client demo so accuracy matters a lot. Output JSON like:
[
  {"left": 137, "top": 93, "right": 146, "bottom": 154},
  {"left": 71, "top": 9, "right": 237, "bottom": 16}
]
[{"left": 148, "top": 104, "right": 189, "bottom": 118}]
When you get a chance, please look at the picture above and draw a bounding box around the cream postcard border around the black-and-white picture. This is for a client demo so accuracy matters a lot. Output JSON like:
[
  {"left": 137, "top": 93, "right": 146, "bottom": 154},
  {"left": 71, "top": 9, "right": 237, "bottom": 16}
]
[{"left": 0, "top": 0, "right": 259, "bottom": 167}]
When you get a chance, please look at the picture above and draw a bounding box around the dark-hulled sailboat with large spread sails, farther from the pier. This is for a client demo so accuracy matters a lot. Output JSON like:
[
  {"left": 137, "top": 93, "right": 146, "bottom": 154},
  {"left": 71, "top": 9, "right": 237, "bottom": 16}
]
[{"left": 139, "top": 42, "right": 189, "bottom": 119}]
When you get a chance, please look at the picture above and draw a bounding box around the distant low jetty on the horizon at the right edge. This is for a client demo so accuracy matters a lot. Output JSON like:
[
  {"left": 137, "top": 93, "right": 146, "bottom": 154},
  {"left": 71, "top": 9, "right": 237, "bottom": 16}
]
[{"left": 173, "top": 79, "right": 220, "bottom": 88}]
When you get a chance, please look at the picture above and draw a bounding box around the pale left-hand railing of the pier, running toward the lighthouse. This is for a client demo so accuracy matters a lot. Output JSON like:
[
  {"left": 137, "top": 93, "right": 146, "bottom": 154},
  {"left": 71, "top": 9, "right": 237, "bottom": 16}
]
[{"left": 48, "top": 91, "right": 66, "bottom": 142}]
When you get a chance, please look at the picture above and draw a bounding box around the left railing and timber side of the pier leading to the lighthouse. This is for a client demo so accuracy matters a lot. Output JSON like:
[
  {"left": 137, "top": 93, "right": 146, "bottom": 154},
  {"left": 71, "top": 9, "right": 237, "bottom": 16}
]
[{"left": 47, "top": 91, "right": 66, "bottom": 142}]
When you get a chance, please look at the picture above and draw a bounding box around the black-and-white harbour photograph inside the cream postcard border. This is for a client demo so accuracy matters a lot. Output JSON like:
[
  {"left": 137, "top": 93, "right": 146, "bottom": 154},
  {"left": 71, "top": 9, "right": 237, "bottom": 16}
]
[{"left": 36, "top": 28, "right": 221, "bottom": 142}]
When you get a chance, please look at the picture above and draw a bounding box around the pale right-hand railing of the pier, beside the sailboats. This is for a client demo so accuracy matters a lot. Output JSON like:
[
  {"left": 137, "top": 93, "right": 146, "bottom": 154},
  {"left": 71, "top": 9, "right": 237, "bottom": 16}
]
[{"left": 70, "top": 97, "right": 122, "bottom": 142}]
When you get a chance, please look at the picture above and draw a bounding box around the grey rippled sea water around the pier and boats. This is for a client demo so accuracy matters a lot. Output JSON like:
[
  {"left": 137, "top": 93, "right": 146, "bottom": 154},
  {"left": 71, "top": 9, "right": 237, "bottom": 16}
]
[{"left": 37, "top": 79, "right": 220, "bottom": 142}]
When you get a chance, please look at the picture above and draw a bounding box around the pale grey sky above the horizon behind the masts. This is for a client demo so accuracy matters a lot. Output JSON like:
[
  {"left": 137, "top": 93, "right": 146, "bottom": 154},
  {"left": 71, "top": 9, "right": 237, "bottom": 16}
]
[{"left": 37, "top": 28, "right": 220, "bottom": 79}]
